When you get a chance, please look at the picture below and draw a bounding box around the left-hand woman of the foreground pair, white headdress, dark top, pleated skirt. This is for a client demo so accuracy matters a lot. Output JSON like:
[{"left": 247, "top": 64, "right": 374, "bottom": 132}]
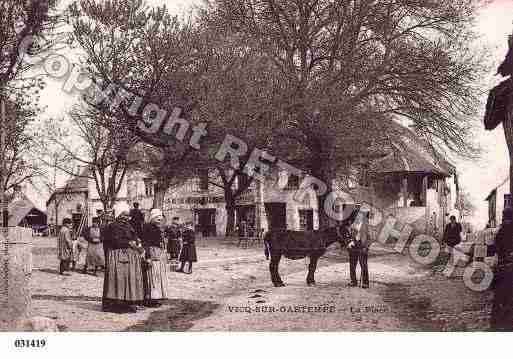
[{"left": 103, "top": 203, "right": 144, "bottom": 313}]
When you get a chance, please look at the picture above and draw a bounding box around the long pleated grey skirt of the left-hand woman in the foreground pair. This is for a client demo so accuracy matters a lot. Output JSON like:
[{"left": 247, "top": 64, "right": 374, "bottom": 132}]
[{"left": 103, "top": 248, "right": 144, "bottom": 304}]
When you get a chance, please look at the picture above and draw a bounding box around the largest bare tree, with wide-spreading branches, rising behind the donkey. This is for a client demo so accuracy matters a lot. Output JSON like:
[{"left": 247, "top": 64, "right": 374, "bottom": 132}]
[{"left": 204, "top": 0, "right": 484, "bottom": 224}]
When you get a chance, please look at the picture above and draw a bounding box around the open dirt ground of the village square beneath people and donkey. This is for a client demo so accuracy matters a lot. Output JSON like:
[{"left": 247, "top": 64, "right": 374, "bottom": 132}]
[{"left": 31, "top": 237, "right": 492, "bottom": 331}]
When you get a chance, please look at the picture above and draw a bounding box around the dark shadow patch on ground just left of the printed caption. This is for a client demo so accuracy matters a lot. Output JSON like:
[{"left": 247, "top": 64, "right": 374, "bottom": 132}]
[{"left": 126, "top": 299, "right": 219, "bottom": 332}]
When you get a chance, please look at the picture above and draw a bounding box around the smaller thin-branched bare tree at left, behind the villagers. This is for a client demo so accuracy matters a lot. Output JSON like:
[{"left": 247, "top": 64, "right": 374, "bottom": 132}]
[{"left": 38, "top": 105, "right": 138, "bottom": 210}]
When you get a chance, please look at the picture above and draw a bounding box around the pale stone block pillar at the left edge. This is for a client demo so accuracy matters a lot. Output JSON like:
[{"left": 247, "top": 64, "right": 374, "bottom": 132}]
[{"left": 0, "top": 227, "right": 32, "bottom": 330}]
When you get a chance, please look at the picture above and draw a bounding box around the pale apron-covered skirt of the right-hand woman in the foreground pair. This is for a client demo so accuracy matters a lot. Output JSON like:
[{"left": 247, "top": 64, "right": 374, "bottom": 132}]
[{"left": 143, "top": 247, "right": 169, "bottom": 299}]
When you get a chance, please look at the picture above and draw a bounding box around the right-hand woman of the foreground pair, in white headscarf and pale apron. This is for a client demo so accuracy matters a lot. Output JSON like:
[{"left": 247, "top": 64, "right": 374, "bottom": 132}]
[{"left": 141, "top": 209, "right": 169, "bottom": 307}]
